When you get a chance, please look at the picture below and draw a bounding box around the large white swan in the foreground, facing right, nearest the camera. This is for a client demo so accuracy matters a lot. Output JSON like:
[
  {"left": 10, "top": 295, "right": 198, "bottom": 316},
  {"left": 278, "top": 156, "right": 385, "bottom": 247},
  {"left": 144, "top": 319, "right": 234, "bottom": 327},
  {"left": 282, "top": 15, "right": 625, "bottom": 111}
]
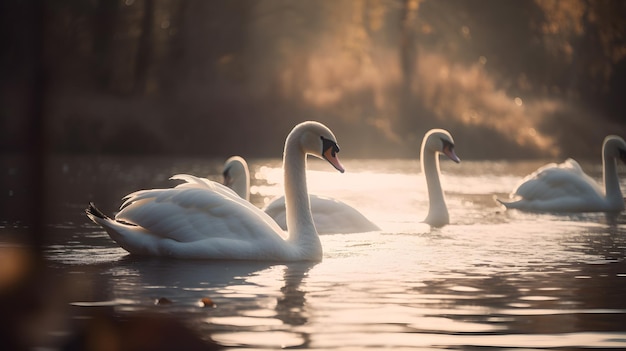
[{"left": 86, "top": 122, "right": 344, "bottom": 261}]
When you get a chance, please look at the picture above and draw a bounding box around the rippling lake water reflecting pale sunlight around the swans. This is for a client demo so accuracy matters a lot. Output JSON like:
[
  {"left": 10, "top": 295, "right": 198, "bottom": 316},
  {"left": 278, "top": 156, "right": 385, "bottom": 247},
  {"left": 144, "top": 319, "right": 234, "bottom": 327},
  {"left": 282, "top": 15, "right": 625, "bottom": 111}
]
[{"left": 0, "top": 155, "right": 626, "bottom": 350}]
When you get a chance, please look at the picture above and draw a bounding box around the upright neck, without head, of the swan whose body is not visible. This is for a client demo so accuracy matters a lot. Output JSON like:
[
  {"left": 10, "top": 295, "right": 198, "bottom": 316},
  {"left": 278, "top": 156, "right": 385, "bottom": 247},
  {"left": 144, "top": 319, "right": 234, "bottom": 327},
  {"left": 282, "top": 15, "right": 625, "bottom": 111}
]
[{"left": 420, "top": 147, "right": 450, "bottom": 227}]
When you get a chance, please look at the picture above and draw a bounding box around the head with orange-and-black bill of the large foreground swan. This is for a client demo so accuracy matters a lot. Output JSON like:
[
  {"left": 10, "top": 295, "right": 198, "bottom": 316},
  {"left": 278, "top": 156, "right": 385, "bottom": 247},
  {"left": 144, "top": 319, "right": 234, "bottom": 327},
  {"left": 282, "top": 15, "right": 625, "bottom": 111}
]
[{"left": 285, "top": 121, "right": 345, "bottom": 173}]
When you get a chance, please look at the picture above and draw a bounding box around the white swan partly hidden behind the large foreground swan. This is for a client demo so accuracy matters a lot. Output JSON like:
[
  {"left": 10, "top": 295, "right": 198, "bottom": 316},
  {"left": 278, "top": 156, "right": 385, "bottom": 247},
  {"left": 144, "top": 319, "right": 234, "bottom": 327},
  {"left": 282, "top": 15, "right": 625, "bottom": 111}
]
[{"left": 222, "top": 156, "right": 380, "bottom": 234}]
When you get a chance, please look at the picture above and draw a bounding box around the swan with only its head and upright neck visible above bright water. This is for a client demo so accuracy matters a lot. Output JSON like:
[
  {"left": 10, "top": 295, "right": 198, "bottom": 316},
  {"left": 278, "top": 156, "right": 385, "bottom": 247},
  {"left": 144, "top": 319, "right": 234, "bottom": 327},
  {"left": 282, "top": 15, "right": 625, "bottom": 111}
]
[{"left": 420, "top": 129, "right": 461, "bottom": 227}]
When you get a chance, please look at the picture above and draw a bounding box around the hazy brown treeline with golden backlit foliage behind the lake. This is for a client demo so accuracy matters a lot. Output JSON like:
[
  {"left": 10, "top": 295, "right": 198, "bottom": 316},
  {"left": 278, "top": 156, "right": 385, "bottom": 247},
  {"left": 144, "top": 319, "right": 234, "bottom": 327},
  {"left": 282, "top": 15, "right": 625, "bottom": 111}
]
[{"left": 0, "top": 0, "right": 626, "bottom": 158}]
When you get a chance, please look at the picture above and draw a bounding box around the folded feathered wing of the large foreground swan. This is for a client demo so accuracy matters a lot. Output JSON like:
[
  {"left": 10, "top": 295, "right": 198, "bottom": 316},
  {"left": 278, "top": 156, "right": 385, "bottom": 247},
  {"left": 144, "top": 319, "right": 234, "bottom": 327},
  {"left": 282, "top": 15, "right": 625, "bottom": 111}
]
[{"left": 115, "top": 175, "right": 283, "bottom": 243}]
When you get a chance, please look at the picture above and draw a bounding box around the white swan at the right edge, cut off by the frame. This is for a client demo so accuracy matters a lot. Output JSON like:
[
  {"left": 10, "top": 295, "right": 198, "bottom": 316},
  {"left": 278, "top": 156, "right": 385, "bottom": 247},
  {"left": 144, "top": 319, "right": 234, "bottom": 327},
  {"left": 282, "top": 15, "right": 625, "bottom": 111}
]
[{"left": 498, "top": 135, "right": 626, "bottom": 212}]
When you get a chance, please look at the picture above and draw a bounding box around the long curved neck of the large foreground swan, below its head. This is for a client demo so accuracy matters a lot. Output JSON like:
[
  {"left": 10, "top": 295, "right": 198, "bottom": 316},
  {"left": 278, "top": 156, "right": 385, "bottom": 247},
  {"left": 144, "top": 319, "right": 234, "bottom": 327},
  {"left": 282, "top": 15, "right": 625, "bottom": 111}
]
[{"left": 283, "top": 136, "right": 322, "bottom": 258}]
